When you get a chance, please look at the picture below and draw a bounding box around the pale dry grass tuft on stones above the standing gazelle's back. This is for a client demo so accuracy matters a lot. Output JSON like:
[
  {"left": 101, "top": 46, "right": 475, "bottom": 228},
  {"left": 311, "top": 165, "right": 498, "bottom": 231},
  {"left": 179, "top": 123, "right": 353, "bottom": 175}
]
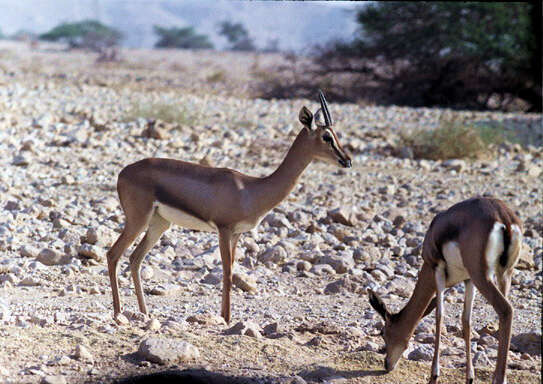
[{"left": 124, "top": 102, "right": 198, "bottom": 125}]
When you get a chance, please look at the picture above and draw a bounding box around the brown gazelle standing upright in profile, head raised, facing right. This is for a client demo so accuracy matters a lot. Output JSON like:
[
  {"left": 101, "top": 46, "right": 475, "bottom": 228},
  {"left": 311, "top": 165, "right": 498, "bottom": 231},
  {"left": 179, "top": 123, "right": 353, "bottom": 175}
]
[{"left": 107, "top": 92, "right": 351, "bottom": 322}]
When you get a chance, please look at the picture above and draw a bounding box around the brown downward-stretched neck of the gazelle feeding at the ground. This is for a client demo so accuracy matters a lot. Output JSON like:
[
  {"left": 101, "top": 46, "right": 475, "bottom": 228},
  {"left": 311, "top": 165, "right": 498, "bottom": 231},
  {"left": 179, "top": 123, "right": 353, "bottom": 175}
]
[{"left": 394, "top": 263, "right": 436, "bottom": 338}]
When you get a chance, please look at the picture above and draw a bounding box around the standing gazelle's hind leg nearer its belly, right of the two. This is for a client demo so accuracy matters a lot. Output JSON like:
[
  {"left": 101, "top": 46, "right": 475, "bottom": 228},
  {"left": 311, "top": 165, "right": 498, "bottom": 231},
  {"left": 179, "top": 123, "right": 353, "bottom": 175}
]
[{"left": 130, "top": 212, "right": 170, "bottom": 314}]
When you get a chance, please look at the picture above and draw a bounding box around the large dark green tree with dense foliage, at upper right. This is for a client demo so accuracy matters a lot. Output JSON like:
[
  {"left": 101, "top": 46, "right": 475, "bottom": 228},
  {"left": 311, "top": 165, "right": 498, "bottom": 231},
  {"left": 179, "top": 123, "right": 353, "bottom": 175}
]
[{"left": 319, "top": 2, "right": 543, "bottom": 111}]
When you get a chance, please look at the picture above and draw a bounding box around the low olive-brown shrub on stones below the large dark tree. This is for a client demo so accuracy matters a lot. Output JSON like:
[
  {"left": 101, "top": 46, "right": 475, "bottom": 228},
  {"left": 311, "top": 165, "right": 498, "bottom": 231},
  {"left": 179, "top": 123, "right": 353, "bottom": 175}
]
[{"left": 398, "top": 120, "right": 506, "bottom": 160}]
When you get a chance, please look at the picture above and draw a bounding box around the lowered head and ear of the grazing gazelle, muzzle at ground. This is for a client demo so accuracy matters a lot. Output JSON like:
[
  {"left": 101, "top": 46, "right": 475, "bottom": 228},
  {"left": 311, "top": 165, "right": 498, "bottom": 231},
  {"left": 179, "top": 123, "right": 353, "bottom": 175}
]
[{"left": 368, "top": 290, "right": 411, "bottom": 372}]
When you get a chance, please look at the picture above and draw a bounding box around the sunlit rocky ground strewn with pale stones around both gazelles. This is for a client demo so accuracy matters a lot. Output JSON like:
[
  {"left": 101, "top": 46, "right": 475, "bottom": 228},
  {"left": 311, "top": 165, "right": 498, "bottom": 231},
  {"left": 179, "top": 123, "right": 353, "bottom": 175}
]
[{"left": 0, "top": 43, "right": 543, "bottom": 383}]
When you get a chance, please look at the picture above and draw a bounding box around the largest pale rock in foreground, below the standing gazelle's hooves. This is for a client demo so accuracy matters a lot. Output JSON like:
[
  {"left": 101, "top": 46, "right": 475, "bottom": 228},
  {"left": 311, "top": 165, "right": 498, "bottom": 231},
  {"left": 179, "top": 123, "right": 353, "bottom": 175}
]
[{"left": 138, "top": 337, "right": 200, "bottom": 365}]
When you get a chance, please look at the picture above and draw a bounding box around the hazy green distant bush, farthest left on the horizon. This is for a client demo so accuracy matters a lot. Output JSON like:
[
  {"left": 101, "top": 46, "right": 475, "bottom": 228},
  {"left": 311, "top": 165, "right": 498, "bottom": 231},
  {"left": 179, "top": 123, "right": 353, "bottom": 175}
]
[{"left": 40, "top": 20, "right": 122, "bottom": 52}]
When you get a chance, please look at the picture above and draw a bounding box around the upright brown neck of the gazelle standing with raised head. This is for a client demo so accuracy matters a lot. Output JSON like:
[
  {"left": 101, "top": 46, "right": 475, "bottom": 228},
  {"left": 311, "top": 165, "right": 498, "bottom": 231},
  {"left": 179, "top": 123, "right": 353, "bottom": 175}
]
[{"left": 260, "top": 128, "right": 312, "bottom": 210}]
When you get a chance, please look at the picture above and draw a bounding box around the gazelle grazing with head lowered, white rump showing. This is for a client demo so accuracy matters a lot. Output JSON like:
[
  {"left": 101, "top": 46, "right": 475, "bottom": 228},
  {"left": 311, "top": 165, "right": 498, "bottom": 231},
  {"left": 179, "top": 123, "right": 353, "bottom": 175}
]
[{"left": 368, "top": 197, "right": 522, "bottom": 384}]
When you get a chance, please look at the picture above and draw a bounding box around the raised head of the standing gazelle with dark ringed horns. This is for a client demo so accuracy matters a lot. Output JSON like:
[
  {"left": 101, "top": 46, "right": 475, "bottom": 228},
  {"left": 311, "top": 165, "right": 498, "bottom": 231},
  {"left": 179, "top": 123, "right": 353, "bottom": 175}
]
[{"left": 298, "top": 91, "right": 351, "bottom": 168}]
